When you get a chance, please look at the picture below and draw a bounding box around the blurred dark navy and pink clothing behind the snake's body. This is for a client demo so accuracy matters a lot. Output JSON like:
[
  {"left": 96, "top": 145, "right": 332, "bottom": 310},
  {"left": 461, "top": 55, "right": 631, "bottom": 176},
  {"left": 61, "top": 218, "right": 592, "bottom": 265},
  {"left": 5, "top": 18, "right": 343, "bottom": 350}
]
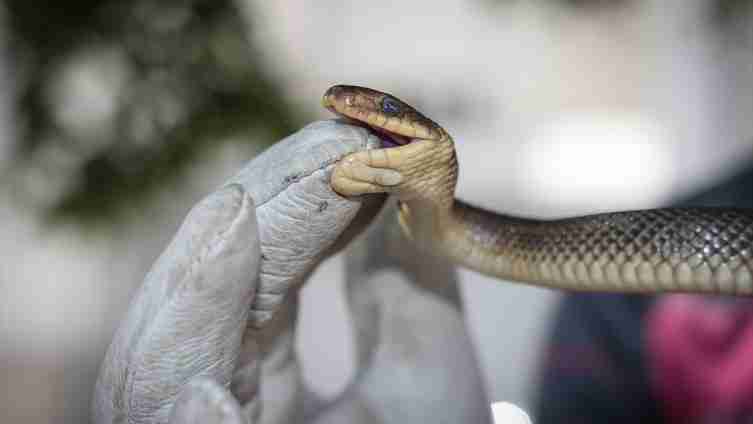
[{"left": 534, "top": 163, "right": 753, "bottom": 424}]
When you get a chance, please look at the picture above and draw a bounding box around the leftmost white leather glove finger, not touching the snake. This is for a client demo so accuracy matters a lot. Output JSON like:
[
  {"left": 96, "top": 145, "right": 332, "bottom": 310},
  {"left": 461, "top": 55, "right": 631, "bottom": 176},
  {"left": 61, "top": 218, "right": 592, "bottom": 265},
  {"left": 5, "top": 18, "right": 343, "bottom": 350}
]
[{"left": 93, "top": 185, "right": 259, "bottom": 423}]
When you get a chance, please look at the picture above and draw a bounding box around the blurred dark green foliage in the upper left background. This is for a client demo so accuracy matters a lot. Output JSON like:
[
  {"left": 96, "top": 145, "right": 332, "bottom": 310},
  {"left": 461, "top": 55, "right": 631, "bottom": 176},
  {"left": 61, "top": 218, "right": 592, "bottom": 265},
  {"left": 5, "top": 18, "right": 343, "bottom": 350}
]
[{"left": 5, "top": 0, "right": 303, "bottom": 218}]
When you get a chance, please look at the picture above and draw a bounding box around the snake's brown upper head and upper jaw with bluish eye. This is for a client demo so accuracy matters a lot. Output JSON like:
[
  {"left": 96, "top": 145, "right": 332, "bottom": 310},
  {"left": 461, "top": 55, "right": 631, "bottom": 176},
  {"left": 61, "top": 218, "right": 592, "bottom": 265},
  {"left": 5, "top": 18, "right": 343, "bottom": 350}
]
[{"left": 322, "top": 85, "right": 449, "bottom": 147}]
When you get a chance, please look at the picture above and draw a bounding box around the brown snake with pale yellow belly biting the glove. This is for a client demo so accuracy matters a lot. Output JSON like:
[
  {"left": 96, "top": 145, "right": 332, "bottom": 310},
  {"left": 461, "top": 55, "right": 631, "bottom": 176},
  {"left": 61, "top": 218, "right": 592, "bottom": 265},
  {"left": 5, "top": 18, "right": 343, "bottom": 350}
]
[{"left": 322, "top": 85, "right": 753, "bottom": 296}]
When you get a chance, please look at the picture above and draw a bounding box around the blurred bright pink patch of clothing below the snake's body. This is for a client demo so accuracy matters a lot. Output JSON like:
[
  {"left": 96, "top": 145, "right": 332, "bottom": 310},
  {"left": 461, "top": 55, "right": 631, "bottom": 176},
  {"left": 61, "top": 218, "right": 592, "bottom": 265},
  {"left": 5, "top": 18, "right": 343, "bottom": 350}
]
[{"left": 646, "top": 295, "right": 753, "bottom": 423}]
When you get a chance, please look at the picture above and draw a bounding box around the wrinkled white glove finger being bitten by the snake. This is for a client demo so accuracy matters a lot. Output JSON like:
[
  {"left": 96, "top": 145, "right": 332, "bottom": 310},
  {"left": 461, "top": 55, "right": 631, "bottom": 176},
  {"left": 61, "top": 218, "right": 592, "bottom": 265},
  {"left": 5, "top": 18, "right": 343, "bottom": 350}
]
[{"left": 226, "top": 121, "right": 383, "bottom": 328}]
